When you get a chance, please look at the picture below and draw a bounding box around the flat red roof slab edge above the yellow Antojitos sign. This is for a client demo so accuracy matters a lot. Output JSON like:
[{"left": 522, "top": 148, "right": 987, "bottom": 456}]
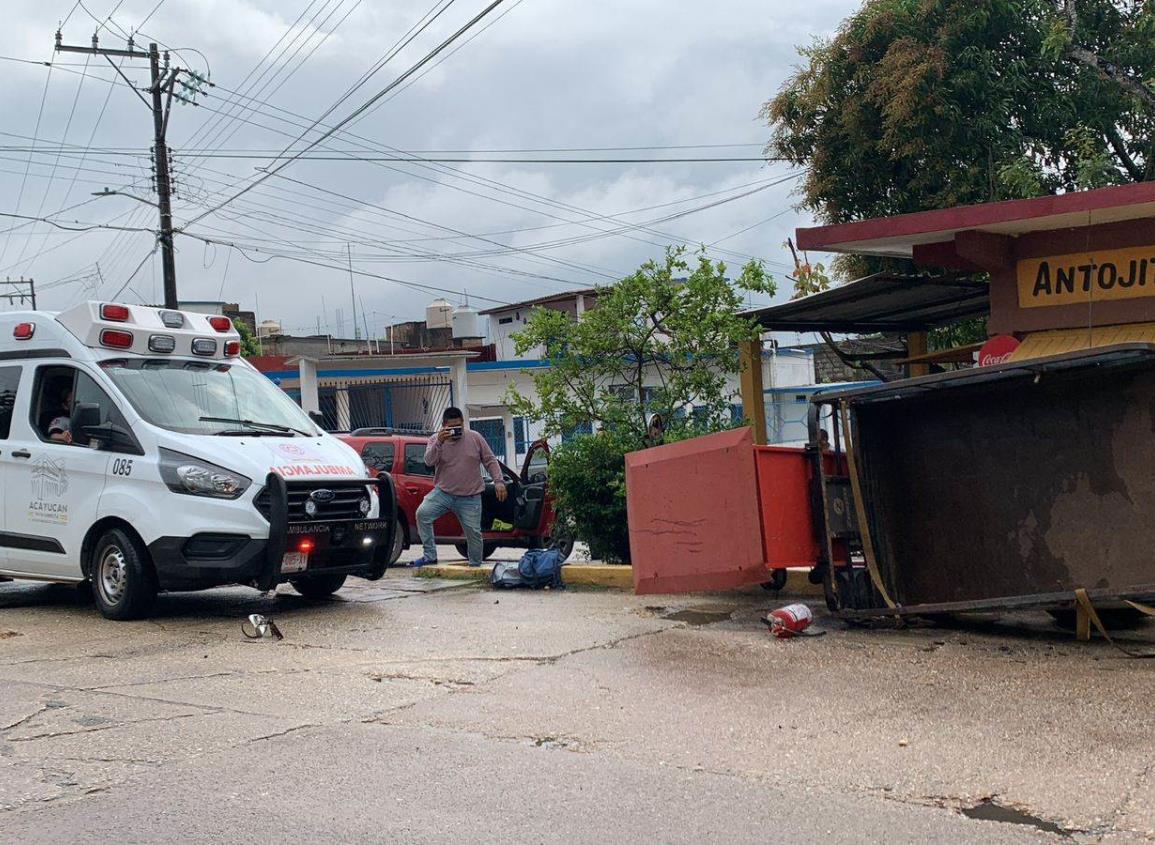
[{"left": 797, "top": 182, "right": 1155, "bottom": 259}]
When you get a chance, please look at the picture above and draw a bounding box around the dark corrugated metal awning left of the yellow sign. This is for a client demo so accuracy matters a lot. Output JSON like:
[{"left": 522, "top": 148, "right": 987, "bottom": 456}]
[{"left": 745, "top": 272, "right": 990, "bottom": 334}]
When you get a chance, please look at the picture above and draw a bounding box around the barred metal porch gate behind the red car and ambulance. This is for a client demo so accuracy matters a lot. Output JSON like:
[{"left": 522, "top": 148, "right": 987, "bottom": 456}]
[{"left": 319, "top": 376, "right": 453, "bottom": 432}]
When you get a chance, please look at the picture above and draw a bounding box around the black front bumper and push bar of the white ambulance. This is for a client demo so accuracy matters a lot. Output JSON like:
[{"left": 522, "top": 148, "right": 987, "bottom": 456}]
[{"left": 149, "top": 472, "right": 396, "bottom": 590}]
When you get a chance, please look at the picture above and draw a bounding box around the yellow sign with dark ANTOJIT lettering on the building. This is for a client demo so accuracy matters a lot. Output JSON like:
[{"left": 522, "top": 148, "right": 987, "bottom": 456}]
[{"left": 1018, "top": 247, "right": 1155, "bottom": 308}]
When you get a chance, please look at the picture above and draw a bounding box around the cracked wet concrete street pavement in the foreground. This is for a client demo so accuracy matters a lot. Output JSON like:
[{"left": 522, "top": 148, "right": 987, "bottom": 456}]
[{"left": 0, "top": 561, "right": 1155, "bottom": 843}]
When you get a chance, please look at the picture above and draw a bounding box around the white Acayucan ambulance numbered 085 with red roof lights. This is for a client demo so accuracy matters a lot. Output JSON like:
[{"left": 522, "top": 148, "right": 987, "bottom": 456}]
[{"left": 0, "top": 302, "right": 396, "bottom": 619}]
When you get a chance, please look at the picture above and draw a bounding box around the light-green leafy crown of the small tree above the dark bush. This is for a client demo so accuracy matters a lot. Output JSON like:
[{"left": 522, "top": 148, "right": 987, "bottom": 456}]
[{"left": 506, "top": 247, "right": 775, "bottom": 443}]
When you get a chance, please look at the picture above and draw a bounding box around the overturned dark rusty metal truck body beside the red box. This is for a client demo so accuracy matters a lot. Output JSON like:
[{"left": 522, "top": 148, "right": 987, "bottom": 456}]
[{"left": 815, "top": 344, "right": 1155, "bottom": 616}]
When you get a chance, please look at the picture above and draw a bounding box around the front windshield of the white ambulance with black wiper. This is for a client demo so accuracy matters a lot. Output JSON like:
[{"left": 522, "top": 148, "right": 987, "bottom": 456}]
[{"left": 100, "top": 359, "right": 316, "bottom": 438}]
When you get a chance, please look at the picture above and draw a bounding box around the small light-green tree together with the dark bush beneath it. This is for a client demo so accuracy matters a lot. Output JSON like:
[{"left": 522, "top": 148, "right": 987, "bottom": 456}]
[{"left": 507, "top": 247, "right": 775, "bottom": 561}]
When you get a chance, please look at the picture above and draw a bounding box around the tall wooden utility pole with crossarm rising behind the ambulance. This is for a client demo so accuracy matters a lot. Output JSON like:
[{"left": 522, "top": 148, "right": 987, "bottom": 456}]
[{"left": 57, "top": 30, "right": 213, "bottom": 308}]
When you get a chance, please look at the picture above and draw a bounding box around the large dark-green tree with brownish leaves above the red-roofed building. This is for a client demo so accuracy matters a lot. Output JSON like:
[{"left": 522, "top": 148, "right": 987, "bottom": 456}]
[{"left": 762, "top": 0, "right": 1155, "bottom": 275}]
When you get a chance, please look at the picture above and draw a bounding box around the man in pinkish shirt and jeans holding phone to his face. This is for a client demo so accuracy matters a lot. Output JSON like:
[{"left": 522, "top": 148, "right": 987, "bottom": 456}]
[{"left": 411, "top": 407, "right": 508, "bottom": 567}]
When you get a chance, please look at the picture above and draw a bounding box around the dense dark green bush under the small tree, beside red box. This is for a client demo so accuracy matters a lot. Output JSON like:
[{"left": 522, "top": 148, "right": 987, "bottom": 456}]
[{"left": 550, "top": 433, "right": 640, "bottom": 562}]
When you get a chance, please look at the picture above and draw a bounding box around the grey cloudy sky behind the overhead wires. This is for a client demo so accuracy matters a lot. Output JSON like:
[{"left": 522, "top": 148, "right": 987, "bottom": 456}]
[{"left": 0, "top": 0, "right": 858, "bottom": 335}]
